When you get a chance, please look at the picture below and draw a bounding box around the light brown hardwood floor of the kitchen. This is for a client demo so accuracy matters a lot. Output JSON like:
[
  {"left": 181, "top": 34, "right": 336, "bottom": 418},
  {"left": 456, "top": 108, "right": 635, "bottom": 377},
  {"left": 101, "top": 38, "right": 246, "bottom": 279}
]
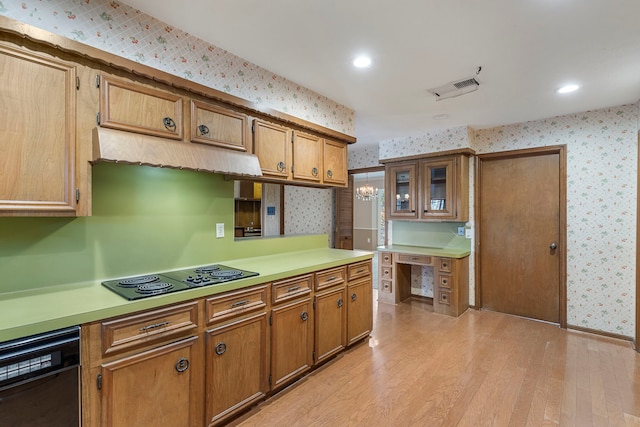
[{"left": 232, "top": 293, "right": 640, "bottom": 427}]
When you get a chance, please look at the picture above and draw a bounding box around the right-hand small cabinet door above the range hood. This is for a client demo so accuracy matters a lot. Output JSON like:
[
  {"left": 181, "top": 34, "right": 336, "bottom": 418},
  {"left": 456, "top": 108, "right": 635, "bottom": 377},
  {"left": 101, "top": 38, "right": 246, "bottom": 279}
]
[{"left": 191, "top": 101, "right": 247, "bottom": 151}]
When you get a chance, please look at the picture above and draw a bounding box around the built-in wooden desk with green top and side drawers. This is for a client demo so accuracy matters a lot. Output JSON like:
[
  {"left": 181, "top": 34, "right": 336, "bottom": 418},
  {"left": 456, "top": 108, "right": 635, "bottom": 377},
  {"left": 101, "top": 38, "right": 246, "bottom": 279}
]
[{"left": 378, "top": 245, "right": 469, "bottom": 316}]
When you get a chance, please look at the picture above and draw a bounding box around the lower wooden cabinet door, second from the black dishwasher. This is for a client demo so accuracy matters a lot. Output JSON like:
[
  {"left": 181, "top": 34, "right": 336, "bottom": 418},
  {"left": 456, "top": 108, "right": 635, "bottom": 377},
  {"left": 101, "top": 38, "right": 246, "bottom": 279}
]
[{"left": 206, "top": 313, "right": 267, "bottom": 425}]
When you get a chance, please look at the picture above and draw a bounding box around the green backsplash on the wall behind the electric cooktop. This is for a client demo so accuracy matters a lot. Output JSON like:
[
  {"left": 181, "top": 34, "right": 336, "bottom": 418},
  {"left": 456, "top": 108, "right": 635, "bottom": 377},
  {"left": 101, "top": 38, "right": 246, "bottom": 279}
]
[{"left": 0, "top": 163, "right": 327, "bottom": 293}]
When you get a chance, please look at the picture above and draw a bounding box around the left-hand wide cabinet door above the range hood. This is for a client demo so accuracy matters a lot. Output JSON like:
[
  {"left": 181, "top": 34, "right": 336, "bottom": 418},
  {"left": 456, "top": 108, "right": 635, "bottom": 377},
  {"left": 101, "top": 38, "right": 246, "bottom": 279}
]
[{"left": 100, "top": 76, "right": 183, "bottom": 139}]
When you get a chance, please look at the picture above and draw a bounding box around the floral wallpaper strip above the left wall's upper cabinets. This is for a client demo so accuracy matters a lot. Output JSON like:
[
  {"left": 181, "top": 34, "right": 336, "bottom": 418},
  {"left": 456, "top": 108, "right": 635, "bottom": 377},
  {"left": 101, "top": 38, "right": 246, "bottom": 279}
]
[{"left": 0, "top": 0, "right": 355, "bottom": 136}]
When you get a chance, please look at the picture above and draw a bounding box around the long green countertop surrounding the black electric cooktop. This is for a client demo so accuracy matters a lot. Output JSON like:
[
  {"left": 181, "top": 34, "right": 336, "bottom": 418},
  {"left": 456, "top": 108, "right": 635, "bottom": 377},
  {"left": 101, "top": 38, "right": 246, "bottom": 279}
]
[{"left": 0, "top": 249, "right": 373, "bottom": 342}]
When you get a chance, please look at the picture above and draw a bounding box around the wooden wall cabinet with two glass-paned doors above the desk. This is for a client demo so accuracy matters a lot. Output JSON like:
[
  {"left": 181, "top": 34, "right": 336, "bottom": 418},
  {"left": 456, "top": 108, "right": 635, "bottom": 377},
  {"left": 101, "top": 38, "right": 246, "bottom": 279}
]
[{"left": 385, "top": 150, "right": 470, "bottom": 222}]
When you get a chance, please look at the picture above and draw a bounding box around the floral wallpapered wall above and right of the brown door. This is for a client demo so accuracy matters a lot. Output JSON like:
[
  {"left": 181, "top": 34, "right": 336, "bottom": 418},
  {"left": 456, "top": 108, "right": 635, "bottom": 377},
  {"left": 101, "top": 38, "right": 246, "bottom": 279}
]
[{"left": 472, "top": 105, "right": 638, "bottom": 336}]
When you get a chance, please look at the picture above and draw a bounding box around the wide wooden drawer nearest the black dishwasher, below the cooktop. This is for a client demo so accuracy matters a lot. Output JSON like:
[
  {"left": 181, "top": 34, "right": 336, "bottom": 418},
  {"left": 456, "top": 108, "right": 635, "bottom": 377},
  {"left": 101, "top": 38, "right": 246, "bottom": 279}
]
[{"left": 102, "top": 301, "right": 198, "bottom": 355}]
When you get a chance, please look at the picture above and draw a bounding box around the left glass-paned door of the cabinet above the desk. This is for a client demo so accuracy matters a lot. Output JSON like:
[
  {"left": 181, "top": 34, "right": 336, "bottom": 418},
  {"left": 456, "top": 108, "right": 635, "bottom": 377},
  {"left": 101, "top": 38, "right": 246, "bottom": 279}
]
[{"left": 385, "top": 162, "right": 418, "bottom": 219}]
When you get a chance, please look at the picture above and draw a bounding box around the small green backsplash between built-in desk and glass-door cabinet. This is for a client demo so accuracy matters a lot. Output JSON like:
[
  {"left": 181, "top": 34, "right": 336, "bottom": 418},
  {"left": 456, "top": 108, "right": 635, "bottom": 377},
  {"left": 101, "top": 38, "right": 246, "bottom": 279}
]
[{"left": 391, "top": 221, "right": 471, "bottom": 250}]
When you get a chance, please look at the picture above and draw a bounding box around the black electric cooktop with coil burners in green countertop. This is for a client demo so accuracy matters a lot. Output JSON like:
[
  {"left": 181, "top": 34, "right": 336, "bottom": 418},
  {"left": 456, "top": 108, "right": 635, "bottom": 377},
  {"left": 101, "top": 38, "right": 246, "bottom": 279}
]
[{"left": 102, "top": 264, "right": 258, "bottom": 300}]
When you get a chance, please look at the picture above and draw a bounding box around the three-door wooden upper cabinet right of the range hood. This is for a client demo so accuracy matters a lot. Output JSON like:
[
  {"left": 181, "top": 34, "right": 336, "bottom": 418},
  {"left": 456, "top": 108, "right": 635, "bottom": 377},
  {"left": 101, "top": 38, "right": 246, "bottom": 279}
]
[{"left": 252, "top": 119, "right": 348, "bottom": 187}]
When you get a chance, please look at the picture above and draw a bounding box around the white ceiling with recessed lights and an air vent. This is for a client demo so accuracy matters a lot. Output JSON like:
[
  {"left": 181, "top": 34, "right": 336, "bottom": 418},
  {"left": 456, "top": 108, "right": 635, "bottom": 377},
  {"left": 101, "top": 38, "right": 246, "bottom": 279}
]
[{"left": 124, "top": 0, "right": 640, "bottom": 144}]
